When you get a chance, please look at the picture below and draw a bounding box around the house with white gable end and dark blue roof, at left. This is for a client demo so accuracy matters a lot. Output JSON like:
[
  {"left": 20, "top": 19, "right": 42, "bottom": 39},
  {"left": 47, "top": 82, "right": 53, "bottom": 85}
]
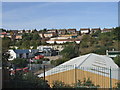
[{"left": 8, "top": 49, "right": 38, "bottom": 60}]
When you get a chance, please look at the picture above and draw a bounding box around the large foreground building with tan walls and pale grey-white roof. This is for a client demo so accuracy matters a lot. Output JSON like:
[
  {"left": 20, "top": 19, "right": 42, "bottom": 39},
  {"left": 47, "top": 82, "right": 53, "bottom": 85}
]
[{"left": 38, "top": 53, "right": 120, "bottom": 88}]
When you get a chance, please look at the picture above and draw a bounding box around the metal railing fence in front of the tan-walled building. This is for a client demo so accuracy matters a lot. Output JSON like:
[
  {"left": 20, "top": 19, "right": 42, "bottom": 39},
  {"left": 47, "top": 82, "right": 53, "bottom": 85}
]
[{"left": 42, "top": 65, "right": 120, "bottom": 88}]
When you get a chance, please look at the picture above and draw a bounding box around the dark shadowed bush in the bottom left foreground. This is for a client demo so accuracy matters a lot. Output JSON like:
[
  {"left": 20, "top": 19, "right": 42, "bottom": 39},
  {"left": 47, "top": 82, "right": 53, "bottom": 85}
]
[{"left": 7, "top": 72, "right": 50, "bottom": 88}]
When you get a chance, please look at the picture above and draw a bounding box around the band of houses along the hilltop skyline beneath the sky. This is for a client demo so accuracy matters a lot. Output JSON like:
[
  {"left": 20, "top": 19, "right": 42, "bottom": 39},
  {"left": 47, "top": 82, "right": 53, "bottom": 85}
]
[{"left": 0, "top": 28, "right": 114, "bottom": 44}]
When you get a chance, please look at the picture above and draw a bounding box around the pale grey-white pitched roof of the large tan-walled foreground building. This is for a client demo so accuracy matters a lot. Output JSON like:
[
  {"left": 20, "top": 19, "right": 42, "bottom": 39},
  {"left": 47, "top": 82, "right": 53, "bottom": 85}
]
[{"left": 38, "top": 53, "right": 119, "bottom": 79}]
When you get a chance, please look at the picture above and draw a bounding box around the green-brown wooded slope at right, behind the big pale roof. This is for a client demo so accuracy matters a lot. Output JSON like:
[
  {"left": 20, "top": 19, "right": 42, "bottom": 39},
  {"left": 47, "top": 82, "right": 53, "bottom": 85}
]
[{"left": 80, "top": 27, "right": 120, "bottom": 55}]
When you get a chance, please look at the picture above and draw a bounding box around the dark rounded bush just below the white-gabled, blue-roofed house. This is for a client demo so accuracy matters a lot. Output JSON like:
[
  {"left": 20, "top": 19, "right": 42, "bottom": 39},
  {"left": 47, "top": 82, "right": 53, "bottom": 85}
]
[{"left": 11, "top": 58, "right": 28, "bottom": 68}]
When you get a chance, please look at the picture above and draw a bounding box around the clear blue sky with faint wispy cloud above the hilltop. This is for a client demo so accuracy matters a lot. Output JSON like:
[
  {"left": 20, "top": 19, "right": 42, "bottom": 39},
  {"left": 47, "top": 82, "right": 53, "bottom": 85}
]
[{"left": 2, "top": 2, "right": 118, "bottom": 30}]
